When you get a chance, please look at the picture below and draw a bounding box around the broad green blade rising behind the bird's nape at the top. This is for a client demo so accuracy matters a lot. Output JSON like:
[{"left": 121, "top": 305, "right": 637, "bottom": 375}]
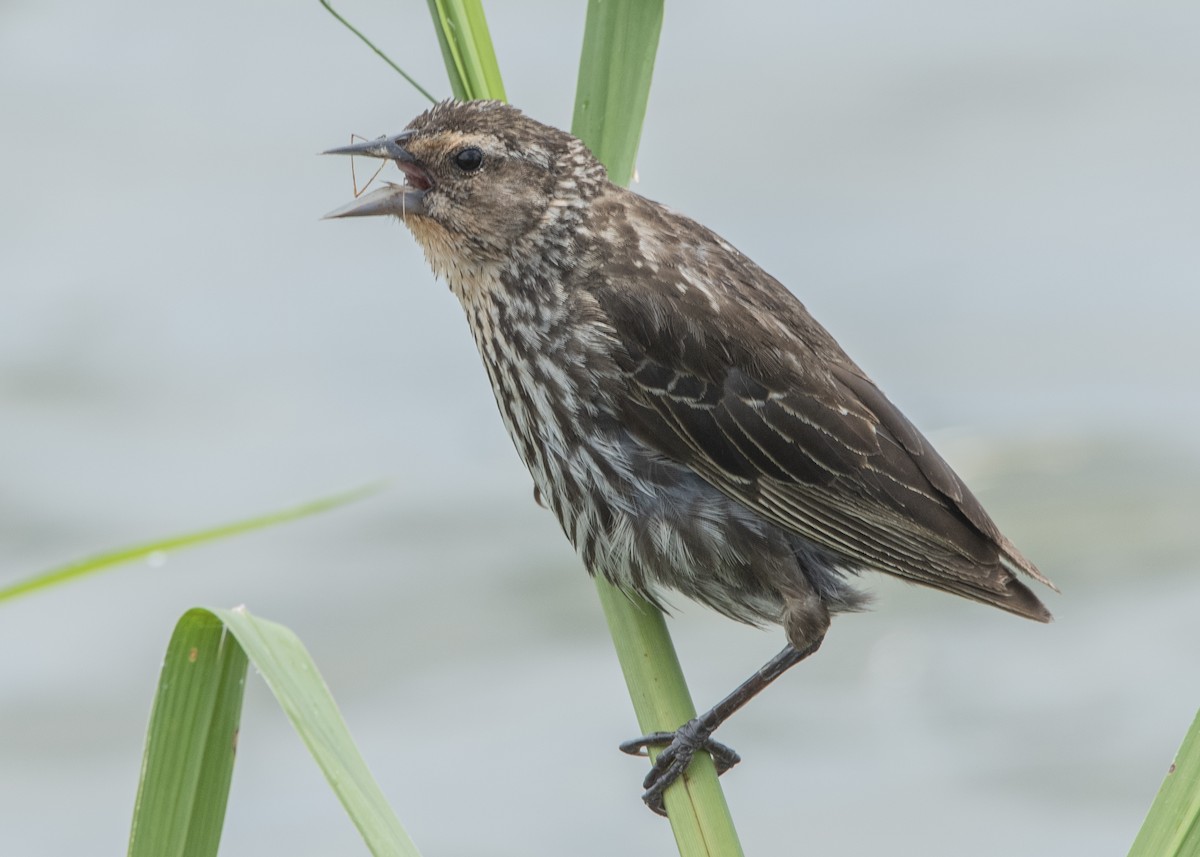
[{"left": 571, "top": 0, "right": 662, "bottom": 185}]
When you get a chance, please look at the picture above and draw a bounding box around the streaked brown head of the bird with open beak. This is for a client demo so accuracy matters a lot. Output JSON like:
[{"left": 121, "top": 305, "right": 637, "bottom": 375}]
[{"left": 326, "top": 101, "right": 605, "bottom": 262}]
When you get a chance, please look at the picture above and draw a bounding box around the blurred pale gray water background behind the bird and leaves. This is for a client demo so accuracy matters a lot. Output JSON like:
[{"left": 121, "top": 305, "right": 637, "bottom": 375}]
[{"left": 0, "top": 0, "right": 1200, "bottom": 857}]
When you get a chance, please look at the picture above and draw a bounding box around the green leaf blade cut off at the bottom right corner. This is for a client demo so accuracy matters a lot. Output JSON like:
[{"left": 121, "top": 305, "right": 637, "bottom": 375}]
[{"left": 1129, "top": 713, "right": 1200, "bottom": 857}]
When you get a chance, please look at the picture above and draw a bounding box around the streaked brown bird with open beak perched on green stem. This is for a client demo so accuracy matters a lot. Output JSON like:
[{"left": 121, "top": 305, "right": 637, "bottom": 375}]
[{"left": 324, "top": 100, "right": 1057, "bottom": 814}]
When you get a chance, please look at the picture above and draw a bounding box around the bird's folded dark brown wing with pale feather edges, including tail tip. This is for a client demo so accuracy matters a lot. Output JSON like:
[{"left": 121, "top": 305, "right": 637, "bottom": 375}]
[{"left": 593, "top": 212, "right": 1052, "bottom": 621}]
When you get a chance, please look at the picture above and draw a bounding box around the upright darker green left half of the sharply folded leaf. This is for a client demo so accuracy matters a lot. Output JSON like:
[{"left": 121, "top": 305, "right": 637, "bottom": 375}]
[{"left": 128, "top": 610, "right": 246, "bottom": 857}]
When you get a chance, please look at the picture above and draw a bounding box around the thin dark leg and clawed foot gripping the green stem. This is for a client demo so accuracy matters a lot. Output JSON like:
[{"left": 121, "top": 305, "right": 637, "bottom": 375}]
[{"left": 620, "top": 640, "right": 821, "bottom": 815}]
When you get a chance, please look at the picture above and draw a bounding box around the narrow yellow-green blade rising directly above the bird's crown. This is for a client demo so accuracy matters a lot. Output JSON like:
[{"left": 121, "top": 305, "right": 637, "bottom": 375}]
[{"left": 428, "top": 0, "right": 508, "bottom": 101}]
